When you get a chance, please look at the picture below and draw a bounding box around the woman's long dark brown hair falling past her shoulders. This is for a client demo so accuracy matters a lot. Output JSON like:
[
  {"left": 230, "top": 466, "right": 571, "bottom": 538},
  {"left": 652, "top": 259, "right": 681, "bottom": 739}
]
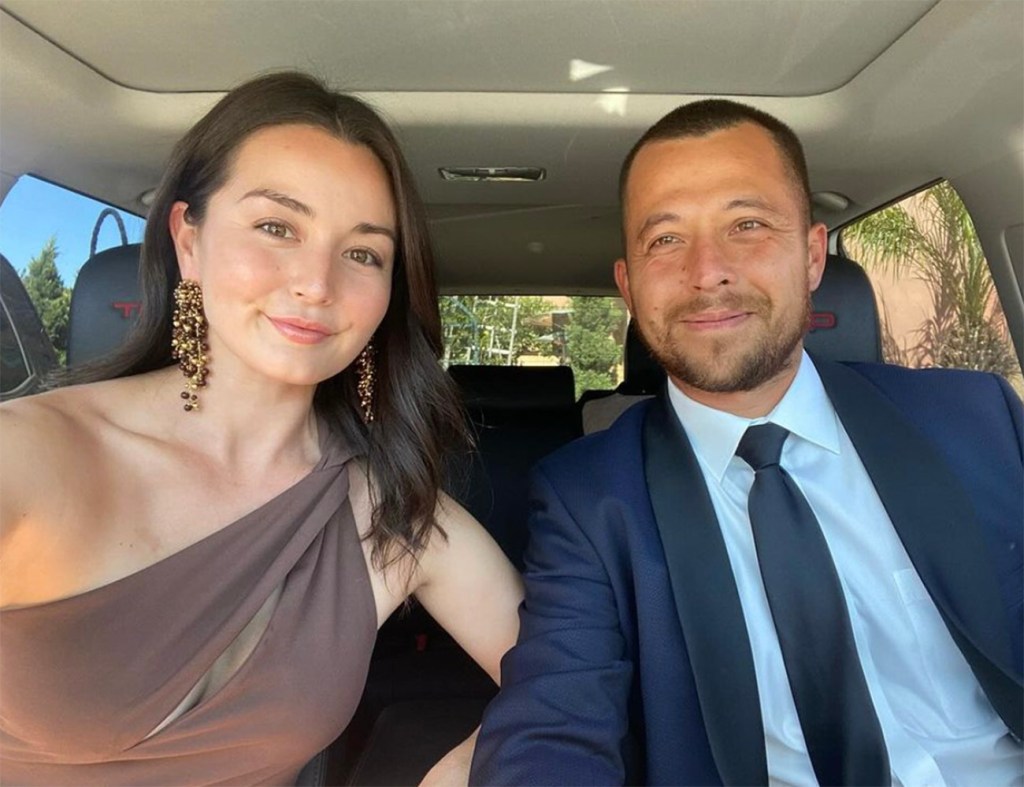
[{"left": 66, "top": 72, "right": 467, "bottom": 567}]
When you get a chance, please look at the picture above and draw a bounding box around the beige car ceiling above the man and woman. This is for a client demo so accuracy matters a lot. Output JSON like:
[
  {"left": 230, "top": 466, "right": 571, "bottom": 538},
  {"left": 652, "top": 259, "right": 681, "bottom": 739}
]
[{"left": 0, "top": 0, "right": 1024, "bottom": 298}]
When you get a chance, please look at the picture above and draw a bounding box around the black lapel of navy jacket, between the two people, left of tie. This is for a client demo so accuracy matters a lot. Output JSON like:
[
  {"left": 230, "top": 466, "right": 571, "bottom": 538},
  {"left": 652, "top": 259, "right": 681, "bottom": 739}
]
[{"left": 643, "top": 394, "right": 768, "bottom": 785}]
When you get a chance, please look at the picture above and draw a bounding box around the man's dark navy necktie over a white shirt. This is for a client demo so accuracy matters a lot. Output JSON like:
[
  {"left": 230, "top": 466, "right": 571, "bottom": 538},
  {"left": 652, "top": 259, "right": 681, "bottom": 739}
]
[{"left": 736, "top": 424, "right": 891, "bottom": 785}]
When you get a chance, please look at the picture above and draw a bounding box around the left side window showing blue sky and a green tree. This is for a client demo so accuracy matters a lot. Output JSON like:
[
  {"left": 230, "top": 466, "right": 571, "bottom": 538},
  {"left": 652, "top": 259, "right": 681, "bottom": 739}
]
[{"left": 0, "top": 175, "right": 145, "bottom": 364}]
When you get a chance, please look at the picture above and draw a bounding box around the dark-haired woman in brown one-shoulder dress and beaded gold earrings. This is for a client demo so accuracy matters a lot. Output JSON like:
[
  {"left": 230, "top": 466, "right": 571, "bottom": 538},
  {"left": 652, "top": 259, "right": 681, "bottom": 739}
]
[{"left": 0, "top": 74, "right": 521, "bottom": 785}]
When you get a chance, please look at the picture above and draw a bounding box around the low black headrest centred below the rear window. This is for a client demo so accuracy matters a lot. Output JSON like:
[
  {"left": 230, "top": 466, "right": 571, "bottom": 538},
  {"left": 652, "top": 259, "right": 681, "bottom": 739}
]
[{"left": 449, "top": 364, "right": 575, "bottom": 410}]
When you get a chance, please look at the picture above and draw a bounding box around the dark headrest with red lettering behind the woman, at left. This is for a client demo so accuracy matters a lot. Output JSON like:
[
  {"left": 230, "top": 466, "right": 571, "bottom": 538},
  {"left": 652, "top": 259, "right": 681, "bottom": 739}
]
[{"left": 68, "top": 244, "right": 142, "bottom": 366}]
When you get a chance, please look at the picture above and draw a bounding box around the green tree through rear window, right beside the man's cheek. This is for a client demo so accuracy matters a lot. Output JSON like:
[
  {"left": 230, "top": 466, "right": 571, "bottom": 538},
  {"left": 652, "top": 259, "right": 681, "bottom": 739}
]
[{"left": 565, "top": 296, "right": 626, "bottom": 397}]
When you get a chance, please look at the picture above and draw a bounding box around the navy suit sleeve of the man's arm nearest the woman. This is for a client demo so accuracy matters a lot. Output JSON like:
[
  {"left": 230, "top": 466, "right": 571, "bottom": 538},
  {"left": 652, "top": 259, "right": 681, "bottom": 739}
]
[{"left": 470, "top": 471, "right": 633, "bottom": 785}]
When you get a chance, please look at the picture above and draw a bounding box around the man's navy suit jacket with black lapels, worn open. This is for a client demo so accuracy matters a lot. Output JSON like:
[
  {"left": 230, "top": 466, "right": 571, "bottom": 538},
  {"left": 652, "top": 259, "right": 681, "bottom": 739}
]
[{"left": 470, "top": 360, "right": 1024, "bottom": 785}]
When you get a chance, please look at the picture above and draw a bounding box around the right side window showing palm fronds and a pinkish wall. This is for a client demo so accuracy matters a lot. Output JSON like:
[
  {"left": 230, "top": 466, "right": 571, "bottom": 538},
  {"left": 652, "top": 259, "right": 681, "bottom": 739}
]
[{"left": 840, "top": 181, "right": 1024, "bottom": 394}]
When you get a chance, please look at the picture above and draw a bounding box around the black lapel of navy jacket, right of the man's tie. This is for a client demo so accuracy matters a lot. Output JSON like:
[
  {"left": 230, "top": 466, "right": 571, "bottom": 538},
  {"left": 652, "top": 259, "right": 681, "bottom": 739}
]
[{"left": 815, "top": 359, "right": 1024, "bottom": 738}]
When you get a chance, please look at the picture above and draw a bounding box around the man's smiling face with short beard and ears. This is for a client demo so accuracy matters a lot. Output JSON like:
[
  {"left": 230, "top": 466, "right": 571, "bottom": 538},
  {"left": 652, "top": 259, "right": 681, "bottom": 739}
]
[{"left": 615, "top": 123, "right": 826, "bottom": 393}]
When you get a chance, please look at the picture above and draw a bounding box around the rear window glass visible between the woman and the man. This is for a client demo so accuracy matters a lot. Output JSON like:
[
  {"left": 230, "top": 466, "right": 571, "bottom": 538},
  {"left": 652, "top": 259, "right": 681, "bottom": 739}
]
[{"left": 440, "top": 295, "right": 627, "bottom": 396}]
